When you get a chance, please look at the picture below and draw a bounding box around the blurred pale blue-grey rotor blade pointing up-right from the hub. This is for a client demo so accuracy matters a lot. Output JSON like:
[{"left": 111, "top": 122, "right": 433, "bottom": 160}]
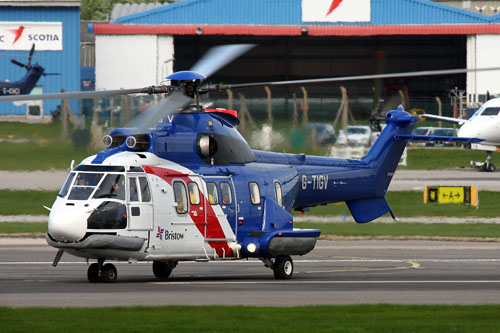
[{"left": 191, "top": 44, "right": 255, "bottom": 77}]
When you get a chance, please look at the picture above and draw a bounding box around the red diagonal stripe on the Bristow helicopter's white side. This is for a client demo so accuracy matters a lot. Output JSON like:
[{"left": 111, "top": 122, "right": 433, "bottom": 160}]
[{"left": 143, "top": 166, "right": 233, "bottom": 257}]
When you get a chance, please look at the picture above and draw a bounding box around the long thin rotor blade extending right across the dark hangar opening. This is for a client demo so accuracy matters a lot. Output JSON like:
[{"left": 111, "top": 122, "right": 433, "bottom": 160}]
[{"left": 200, "top": 67, "right": 500, "bottom": 93}]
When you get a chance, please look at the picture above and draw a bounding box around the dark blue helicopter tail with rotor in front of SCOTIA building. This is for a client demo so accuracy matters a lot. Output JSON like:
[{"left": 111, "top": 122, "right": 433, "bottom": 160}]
[{"left": 0, "top": 43, "right": 59, "bottom": 96}]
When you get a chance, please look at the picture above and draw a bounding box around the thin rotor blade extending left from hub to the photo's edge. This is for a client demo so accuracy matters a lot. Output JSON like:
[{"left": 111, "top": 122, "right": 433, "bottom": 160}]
[{"left": 0, "top": 87, "right": 149, "bottom": 102}]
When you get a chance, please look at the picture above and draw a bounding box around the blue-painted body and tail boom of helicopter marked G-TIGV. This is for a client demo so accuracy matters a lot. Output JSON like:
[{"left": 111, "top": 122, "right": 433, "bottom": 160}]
[{"left": 92, "top": 110, "right": 417, "bottom": 245}]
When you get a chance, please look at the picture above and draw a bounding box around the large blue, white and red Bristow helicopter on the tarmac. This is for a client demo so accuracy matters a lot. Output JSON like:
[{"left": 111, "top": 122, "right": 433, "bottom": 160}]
[{"left": 0, "top": 44, "right": 481, "bottom": 283}]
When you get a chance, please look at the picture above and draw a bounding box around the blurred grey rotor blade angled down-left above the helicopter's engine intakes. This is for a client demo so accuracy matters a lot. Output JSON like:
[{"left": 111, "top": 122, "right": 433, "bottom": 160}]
[{"left": 124, "top": 91, "right": 192, "bottom": 133}]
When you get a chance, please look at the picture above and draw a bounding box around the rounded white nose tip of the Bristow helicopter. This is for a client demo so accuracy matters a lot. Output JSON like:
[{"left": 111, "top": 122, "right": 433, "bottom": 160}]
[{"left": 49, "top": 202, "right": 87, "bottom": 242}]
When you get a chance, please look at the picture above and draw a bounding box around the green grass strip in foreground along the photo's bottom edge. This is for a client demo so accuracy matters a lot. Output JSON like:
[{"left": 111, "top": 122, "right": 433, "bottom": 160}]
[{"left": 0, "top": 304, "right": 500, "bottom": 333}]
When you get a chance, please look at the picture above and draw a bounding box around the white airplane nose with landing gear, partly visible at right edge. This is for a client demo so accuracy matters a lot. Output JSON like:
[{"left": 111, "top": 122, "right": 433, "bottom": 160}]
[{"left": 422, "top": 98, "right": 500, "bottom": 172}]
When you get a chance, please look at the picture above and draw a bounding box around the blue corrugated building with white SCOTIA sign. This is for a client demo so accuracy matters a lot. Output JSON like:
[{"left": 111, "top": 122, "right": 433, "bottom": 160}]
[{"left": 0, "top": 0, "right": 80, "bottom": 114}]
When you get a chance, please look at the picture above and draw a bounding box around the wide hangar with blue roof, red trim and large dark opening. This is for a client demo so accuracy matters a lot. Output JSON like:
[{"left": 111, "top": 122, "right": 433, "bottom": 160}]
[{"left": 89, "top": 0, "right": 500, "bottom": 118}]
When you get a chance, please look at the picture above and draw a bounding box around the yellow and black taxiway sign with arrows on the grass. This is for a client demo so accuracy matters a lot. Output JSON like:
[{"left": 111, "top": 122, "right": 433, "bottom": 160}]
[{"left": 424, "top": 186, "right": 479, "bottom": 207}]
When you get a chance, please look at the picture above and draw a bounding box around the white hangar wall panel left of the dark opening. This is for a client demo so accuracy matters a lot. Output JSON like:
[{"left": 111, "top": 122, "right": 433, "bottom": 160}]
[{"left": 95, "top": 35, "right": 174, "bottom": 90}]
